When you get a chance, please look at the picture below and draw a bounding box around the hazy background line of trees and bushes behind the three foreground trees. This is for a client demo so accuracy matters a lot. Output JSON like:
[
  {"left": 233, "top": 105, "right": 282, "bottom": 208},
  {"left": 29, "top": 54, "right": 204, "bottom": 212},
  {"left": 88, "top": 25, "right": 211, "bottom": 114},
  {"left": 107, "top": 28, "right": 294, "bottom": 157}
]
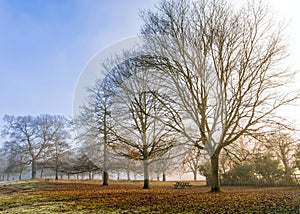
[{"left": 0, "top": 115, "right": 300, "bottom": 185}]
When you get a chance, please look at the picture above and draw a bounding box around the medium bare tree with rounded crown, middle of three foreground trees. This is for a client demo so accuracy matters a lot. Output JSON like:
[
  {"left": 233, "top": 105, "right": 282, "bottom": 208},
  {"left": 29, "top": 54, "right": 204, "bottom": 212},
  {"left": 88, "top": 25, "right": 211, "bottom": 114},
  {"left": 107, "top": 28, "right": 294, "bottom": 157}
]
[{"left": 106, "top": 60, "right": 176, "bottom": 189}]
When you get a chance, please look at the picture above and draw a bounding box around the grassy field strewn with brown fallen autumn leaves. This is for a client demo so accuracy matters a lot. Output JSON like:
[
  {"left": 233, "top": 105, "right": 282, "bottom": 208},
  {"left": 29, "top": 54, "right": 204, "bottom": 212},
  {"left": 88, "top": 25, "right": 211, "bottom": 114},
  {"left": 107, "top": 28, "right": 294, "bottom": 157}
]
[{"left": 0, "top": 180, "right": 300, "bottom": 214}]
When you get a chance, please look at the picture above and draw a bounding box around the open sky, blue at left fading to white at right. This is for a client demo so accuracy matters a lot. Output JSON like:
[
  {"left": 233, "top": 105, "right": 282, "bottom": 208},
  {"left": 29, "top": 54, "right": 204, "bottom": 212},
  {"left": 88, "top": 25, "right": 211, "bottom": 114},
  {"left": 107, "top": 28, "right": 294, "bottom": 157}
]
[{"left": 0, "top": 0, "right": 300, "bottom": 141}]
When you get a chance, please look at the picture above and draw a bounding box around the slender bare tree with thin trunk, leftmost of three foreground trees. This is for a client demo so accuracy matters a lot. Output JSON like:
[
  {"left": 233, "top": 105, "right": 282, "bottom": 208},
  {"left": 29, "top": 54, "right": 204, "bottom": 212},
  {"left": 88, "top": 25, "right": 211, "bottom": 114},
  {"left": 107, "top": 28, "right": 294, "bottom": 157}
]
[{"left": 76, "top": 80, "right": 113, "bottom": 186}]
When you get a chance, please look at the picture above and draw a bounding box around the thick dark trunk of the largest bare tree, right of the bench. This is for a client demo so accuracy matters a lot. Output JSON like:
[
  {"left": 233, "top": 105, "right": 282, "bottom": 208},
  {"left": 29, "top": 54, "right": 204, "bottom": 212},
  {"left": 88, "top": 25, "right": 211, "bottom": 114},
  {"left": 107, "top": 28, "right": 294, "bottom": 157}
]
[{"left": 210, "top": 152, "right": 221, "bottom": 192}]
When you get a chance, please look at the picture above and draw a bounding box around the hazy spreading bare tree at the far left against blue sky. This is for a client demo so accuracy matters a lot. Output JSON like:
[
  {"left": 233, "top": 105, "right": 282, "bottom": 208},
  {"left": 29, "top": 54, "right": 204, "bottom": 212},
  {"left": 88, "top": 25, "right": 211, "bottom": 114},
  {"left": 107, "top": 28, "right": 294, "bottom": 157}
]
[{"left": 3, "top": 115, "right": 69, "bottom": 179}]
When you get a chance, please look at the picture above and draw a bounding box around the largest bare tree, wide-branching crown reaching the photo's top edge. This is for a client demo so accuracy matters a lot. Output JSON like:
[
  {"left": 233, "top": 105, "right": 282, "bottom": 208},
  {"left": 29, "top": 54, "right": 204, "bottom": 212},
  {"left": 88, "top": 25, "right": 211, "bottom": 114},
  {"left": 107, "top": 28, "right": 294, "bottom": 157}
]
[{"left": 140, "top": 0, "right": 298, "bottom": 192}]
